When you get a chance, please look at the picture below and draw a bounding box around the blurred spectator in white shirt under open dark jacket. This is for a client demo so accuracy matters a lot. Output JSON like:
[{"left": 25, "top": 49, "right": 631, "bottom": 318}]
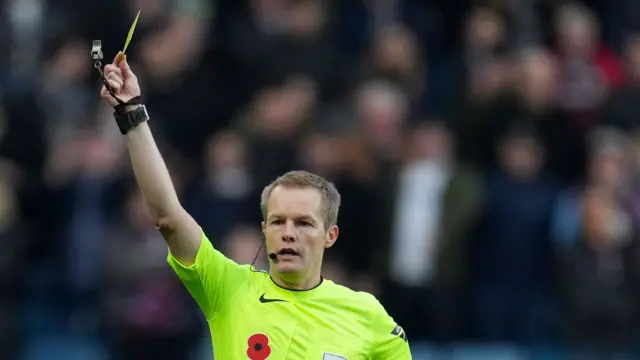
[{"left": 385, "top": 122, "right": 482, "bottom": 340}]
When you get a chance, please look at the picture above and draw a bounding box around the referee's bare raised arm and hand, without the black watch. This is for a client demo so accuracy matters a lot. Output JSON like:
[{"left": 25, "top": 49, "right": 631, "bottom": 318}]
[{"left": 100, "top": 53, "right": 202, "bottom": 266}]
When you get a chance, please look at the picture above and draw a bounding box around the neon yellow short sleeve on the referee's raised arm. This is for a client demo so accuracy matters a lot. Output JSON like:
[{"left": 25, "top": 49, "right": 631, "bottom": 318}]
[{"left": 167, "top": 233, "right": 251, "bottom": 320}]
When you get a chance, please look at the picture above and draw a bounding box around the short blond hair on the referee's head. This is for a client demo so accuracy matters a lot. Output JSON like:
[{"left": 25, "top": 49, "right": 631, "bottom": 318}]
[{"left": 260, "top": 170, "right": 341, "bottom": 229}]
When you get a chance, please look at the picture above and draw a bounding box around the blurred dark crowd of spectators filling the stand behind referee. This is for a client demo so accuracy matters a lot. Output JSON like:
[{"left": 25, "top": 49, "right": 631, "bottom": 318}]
[{"left": 0, "top": 0, "right": 640, "bottom": 360}]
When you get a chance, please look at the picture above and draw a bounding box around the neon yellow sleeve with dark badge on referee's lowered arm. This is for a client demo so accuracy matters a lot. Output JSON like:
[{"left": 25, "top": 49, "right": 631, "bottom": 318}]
[{"left": 370, "top": 300, "right": 411, "bottom": 360}]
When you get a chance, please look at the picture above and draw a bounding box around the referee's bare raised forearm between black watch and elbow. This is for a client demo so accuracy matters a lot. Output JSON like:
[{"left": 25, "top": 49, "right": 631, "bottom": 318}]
[{"left": 126, "top": 122, "right": 182, "bottom": 221}]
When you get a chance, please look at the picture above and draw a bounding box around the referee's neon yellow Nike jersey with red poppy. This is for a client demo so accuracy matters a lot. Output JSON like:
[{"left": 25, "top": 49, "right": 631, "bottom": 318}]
[{"left": 168, "top": 234, "right": 411, "bottom": 360}]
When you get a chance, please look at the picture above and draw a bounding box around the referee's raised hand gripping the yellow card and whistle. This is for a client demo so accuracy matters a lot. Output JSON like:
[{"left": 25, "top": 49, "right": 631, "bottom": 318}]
[{"left": 100, "top": 52, "right": 140, "bottom": 107}]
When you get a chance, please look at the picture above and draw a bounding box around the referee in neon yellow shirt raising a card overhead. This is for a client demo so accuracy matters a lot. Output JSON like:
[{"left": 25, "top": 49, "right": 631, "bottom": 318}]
[{"left": 101, "top": 53, "right": 411, "bottom": 360}]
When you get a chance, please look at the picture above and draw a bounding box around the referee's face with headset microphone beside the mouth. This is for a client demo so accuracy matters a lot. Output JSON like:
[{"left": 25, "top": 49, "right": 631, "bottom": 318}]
[{"left": 262, "top": 186, "right": 338, "bottom": 281}]
